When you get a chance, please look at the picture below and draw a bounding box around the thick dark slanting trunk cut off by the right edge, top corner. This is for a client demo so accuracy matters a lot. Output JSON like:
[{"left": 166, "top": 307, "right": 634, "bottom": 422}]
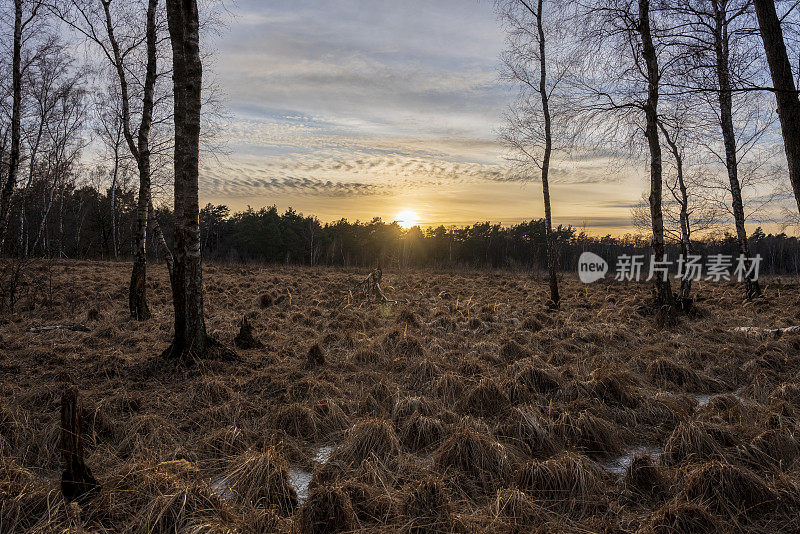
[{"left": 753, "top": 0, "right": 800, "bottom": 220}]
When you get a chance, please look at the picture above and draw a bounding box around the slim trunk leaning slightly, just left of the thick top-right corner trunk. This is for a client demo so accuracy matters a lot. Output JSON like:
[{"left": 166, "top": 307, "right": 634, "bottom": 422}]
[{"left": 714, "top": 0, "right": 761, "bottom": 299}]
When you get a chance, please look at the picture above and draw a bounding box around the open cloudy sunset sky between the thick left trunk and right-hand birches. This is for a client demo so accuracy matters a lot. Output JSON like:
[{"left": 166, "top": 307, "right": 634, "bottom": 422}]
[{"left": 200, "top": 0, "right": 664, "bottom": 234}]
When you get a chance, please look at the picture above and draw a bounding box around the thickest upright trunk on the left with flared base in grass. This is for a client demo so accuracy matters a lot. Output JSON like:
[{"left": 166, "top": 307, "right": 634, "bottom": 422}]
[{"left": 164, "top": 0, "right": 230, "bottom": 363}]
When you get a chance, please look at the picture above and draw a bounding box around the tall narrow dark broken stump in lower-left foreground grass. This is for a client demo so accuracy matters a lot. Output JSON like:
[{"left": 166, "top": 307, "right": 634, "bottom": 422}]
[{"left": 61, "top": 387, "right": 100, "bottom": 502}]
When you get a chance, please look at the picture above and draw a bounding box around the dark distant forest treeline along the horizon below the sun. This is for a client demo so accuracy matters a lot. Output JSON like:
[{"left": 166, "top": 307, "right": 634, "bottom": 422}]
[{"left": 9, "top": 180, "right": 800, "bottom": 274}]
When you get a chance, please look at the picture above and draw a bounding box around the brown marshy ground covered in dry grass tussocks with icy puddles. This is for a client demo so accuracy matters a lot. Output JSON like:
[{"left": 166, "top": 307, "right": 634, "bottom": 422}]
[{"left": 0, "top": 261, "right": 800, "bottom": 533}]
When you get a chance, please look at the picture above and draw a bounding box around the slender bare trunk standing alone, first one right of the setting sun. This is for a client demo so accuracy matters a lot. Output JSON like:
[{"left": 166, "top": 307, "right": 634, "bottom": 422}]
[{"left": 536, "top": 0, "right": 561, "bottom": 307}]
